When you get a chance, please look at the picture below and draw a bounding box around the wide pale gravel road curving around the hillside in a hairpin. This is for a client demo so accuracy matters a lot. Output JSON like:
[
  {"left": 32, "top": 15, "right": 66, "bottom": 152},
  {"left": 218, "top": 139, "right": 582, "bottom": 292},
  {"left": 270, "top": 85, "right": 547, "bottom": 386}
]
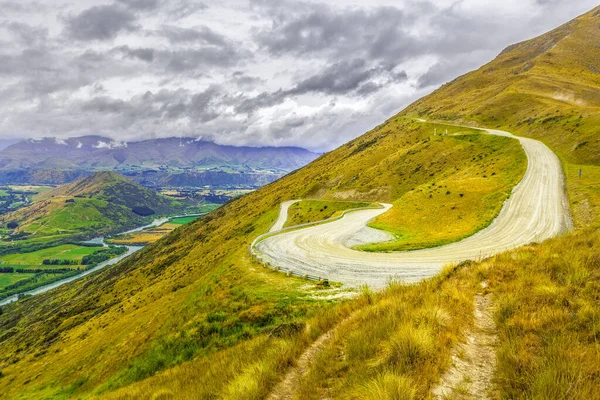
[{"left": 252, "top": 126, "right": 572, "bottom": 288}]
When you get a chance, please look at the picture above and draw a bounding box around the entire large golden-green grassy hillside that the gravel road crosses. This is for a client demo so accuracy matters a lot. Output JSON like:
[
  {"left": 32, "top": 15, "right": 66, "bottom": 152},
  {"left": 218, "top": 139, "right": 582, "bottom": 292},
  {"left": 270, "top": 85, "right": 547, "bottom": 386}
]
[{"left": 0, "top": 9, "right": 600, "bottom": 399}]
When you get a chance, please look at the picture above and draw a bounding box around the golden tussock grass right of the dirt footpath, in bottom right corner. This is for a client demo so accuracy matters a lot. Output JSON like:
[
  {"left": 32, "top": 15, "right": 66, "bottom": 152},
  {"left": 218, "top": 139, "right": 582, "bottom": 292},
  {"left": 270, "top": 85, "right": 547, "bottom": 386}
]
[{"left": 486, "top": 230, "right": 600, "bottom": 399}]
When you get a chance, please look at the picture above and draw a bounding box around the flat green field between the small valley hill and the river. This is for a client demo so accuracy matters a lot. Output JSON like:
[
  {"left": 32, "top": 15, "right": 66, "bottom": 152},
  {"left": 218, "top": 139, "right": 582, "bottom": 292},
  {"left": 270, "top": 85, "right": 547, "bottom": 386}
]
[{"left": 0, "top": 244, "right": 99, "bottom": 268}]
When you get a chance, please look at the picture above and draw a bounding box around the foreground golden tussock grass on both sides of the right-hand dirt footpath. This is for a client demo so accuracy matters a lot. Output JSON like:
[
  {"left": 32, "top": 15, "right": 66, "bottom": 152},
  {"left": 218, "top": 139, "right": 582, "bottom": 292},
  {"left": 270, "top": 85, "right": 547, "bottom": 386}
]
[{"left": 290, "top": 231, "right": 600, "bottom": 399}]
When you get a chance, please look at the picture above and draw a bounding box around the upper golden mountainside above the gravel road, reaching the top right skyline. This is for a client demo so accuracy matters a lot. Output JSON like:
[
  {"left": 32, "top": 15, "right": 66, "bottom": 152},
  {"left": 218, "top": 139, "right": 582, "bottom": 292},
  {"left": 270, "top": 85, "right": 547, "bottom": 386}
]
[{"left": 404, "top": 8, "right": 600, "bottom": 165}]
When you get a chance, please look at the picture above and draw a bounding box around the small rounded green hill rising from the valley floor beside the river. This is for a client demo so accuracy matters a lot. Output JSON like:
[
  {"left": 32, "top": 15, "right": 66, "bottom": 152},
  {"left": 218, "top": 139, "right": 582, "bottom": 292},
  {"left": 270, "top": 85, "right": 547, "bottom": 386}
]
[{"left": 0, "top": 172, "right": 187, "bottom": 251}]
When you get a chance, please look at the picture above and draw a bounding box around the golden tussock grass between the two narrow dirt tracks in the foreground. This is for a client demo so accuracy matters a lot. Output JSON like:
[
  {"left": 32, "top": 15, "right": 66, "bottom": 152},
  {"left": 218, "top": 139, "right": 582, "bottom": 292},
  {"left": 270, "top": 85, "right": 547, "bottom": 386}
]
[{"left": 297, "top": 267, "right": 479, "bottom": 399}]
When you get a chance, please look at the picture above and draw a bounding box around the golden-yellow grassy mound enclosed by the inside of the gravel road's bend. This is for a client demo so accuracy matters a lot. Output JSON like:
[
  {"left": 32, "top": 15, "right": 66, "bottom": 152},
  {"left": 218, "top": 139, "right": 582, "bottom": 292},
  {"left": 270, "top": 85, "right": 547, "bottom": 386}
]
[{"left": 361, "top": 135, "right": 527, "bottom": 251}]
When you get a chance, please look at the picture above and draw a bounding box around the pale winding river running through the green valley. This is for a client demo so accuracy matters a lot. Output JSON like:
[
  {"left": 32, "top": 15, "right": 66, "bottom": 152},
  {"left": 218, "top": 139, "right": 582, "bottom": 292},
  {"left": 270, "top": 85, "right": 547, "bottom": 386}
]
[{"left": 0, "top": 213, "right": 204, "bottom": 306}]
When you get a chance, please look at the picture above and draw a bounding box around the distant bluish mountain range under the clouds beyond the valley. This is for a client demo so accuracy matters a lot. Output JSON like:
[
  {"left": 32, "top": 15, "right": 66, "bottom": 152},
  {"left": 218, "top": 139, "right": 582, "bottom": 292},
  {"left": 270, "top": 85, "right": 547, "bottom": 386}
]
[{"left": 0, "top": 136, "right": 318, "bottom": 186}]
